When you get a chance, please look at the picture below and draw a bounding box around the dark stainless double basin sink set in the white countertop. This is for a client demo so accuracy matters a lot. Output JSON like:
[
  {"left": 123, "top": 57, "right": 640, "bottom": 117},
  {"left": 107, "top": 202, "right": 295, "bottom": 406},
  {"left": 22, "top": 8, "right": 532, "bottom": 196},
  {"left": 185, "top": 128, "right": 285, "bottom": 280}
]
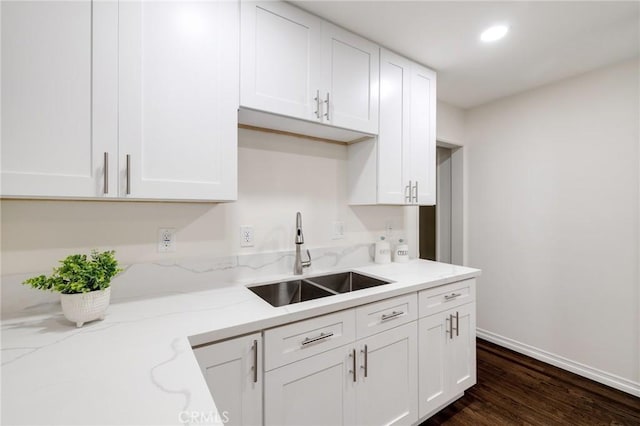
[{"left": 248, "top": 272, "right": 391, "bottom": 307}]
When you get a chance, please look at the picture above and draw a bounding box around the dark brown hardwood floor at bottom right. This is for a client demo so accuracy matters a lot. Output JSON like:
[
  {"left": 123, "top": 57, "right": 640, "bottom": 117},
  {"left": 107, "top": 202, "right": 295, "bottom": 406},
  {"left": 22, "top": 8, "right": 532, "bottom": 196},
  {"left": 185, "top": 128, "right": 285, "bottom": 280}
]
[{"left": 420, "top": 339, "right": 640, "bottom": 426}]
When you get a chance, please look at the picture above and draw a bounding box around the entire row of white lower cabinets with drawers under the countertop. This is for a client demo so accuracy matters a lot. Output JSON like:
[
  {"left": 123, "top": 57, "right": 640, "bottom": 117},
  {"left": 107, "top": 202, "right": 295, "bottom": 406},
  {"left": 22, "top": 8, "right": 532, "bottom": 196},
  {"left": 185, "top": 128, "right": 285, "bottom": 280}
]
[{"left": 194, "top": 280, "right": 476, "bottom": 426}]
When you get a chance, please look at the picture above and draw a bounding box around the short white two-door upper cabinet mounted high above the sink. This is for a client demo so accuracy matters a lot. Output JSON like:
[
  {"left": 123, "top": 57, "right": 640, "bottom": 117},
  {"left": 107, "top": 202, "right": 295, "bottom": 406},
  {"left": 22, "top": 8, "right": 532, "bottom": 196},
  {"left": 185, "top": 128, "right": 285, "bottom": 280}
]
[{"left": 240, "top": 2, "right": 379, "bottom": 134}]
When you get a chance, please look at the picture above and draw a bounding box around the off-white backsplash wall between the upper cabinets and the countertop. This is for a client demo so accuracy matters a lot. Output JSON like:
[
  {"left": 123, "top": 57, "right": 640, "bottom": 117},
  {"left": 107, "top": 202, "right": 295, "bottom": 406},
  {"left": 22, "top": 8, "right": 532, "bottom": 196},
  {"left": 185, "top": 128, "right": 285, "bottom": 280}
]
[{"left": 1, "top": 130, "right": 404, "bottom": 274}]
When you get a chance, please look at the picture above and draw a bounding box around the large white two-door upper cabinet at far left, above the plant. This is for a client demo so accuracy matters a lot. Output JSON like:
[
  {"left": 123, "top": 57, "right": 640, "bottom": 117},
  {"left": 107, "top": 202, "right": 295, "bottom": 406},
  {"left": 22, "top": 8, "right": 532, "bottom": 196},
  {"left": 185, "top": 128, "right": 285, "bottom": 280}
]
[{"left": 1, "top": 1, "right": 239, "bottom": 201}]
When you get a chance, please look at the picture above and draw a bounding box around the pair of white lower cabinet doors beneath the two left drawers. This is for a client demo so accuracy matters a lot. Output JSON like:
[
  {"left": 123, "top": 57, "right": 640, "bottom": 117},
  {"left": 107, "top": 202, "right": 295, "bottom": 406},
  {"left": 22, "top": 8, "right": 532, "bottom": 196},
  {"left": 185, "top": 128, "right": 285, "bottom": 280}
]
[{"left": 264, "top": 321, "right": 418, "bottom": 426}]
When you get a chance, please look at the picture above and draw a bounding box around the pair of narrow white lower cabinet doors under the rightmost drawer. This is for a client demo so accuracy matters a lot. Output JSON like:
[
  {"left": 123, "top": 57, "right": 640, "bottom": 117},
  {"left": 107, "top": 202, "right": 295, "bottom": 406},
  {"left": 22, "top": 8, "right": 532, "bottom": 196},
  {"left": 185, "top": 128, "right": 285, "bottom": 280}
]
[{"left": 418, "top": 303, "right": 476, "bottom": 418}]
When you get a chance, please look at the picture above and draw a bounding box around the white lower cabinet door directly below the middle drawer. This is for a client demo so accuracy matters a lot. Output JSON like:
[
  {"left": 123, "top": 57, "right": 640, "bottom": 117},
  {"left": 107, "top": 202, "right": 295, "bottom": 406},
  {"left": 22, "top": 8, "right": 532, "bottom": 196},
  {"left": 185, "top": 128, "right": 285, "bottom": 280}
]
[{"left": 356, "top": 321, "right": 418, "bottom": 425}]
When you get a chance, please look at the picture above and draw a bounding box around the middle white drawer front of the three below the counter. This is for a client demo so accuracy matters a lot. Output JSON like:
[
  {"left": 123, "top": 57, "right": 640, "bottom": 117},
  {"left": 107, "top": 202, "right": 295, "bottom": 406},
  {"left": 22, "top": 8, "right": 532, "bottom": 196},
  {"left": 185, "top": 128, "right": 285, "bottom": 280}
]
[{"left": 356, "top": 293, "right": 418, "bottom": 339}]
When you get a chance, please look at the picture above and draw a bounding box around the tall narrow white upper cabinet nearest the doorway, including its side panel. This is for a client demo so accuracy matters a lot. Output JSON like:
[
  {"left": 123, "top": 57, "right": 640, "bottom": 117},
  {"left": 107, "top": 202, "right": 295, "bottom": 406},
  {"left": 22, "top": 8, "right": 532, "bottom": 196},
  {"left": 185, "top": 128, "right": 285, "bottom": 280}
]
[{"left": 349, "top": 49, "right": 436, "bottom": 205}]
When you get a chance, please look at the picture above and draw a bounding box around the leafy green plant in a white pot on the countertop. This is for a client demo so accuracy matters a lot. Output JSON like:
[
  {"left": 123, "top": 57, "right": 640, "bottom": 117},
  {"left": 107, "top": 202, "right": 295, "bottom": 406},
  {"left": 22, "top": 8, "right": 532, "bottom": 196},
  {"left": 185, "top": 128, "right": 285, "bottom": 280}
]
[{"left": 23, "top": 250, "right": 122, "bottom": 327}]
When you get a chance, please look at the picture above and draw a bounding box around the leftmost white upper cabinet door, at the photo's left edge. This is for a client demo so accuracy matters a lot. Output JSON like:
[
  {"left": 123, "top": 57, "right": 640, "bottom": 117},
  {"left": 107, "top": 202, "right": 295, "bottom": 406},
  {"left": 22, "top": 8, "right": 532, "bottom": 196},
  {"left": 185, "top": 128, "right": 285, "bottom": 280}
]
[{"left": 0, "top": 1, "right": 118, "bottom": 197}]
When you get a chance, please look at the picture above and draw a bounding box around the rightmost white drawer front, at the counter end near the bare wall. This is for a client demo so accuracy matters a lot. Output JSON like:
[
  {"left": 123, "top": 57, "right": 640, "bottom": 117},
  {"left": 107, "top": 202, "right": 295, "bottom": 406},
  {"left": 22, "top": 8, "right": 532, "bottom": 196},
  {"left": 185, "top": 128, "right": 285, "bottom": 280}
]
[{"left": 418, "top": 280, "right": 476, "bottom": 318}]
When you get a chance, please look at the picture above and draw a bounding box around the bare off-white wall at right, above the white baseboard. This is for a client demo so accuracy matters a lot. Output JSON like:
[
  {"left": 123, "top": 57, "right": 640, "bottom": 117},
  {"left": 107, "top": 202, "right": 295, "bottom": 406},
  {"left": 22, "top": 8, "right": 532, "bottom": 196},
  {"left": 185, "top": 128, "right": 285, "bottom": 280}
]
[{"left": 465, "top": 60, "right": 640, "bottom": 390}]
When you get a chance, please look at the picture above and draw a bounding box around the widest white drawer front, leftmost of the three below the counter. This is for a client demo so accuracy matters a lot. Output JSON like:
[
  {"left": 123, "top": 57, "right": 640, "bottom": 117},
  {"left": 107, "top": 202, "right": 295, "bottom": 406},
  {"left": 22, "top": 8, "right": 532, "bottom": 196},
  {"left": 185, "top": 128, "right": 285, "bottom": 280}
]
[{"left": 264, "top": 309, "right": 356, "bottom": 371}]
